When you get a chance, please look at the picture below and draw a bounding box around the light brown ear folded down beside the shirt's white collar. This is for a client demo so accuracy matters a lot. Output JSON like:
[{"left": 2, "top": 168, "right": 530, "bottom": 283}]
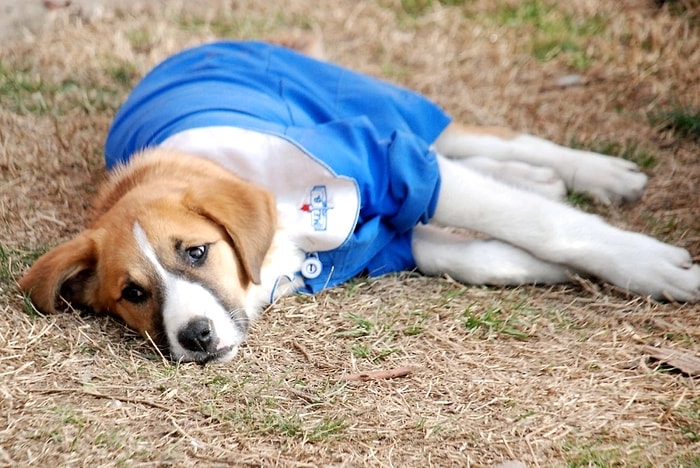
[{"left": 184, "top": 178, "right": 277, "bottom": 284}]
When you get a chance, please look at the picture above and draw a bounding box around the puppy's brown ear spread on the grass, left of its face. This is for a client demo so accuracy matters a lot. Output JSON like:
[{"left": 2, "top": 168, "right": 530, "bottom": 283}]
[{"left": 19, "top": 230, "right": 97, "bottom": 314}]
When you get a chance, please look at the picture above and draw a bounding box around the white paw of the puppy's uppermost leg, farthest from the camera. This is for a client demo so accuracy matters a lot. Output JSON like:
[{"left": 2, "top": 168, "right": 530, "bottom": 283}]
[{"left": 563, "top": 150, "right": 647, "bottom": 204}]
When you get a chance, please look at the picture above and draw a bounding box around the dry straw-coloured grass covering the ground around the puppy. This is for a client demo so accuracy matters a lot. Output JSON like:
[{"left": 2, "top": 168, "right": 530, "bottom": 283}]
[{"left": 0, "top": 0, "right": 700, "bottom": 467}]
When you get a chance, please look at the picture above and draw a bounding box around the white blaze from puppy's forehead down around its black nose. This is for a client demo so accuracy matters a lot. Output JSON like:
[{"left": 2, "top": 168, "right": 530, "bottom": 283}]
[{"left": 133, "top": 223, "right": 245, "bottom": 361}]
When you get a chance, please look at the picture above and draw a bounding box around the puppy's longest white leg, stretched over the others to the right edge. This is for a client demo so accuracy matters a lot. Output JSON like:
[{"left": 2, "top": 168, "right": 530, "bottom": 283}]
[{"left": 433, "top": 156, "right": 700, "bottom": 301}]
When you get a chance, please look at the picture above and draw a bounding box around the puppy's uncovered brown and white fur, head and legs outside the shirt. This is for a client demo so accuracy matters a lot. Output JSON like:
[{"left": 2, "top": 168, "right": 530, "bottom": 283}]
[{"left": 20, "top": 40, "right": 700, "bottom": 363}]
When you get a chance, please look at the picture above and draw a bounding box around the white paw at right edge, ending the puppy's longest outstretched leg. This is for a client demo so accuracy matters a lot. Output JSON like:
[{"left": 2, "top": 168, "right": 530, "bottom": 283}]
[{"left": 600, "top": 234, "right": 700, "bottom": 302}]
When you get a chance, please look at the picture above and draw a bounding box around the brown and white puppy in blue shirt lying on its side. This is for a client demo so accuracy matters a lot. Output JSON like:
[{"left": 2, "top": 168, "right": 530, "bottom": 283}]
[{"left": 20, "top": 42, "right": 700, "bottom": 363}]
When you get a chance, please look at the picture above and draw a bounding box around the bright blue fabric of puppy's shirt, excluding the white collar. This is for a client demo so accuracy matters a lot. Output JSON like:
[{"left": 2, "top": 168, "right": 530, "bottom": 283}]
[{"left": 105, "top": 42, "right": 450, "bottom": 292}]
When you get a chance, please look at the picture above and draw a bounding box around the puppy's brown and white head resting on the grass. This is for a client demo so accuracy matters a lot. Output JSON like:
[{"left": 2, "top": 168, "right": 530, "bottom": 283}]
[{"left": 19, "top": 154, "right": 276, "bottom": 363}]
